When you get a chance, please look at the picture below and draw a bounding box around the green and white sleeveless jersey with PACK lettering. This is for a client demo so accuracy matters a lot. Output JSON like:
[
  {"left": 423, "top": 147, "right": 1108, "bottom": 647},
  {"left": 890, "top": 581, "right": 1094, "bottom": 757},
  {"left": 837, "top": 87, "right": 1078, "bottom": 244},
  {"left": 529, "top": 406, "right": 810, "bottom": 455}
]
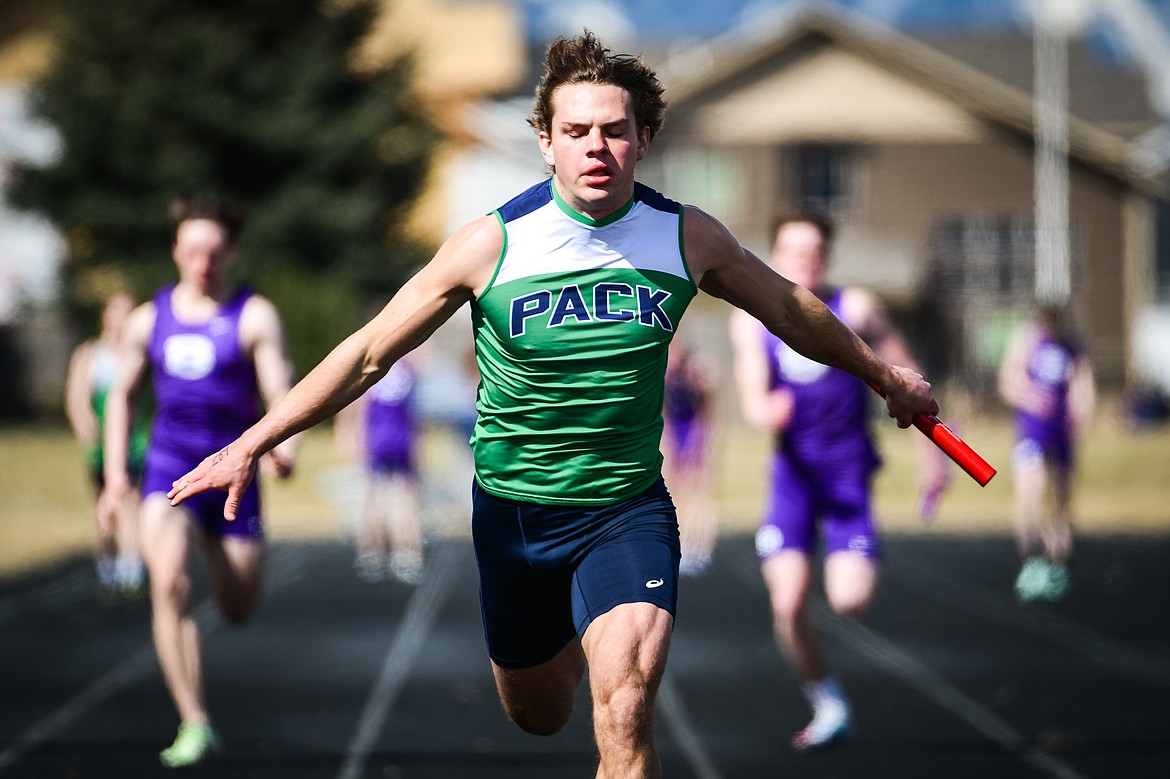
[{"left": 472, "top": 180, "right": 696, "bottom": 505}]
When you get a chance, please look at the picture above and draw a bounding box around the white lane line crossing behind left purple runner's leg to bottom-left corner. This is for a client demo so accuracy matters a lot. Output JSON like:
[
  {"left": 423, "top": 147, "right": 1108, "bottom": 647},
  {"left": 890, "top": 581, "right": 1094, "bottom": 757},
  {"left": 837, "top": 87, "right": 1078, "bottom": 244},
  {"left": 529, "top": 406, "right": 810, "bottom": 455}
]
[{"left": 0, "top": 542, "right": 303, "bottom": 772}]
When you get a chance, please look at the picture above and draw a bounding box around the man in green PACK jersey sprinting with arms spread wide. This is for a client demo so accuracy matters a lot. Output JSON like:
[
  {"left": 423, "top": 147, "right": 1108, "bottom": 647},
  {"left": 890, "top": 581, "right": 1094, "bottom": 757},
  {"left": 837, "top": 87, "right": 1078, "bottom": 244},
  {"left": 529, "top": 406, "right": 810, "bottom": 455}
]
[{"left": 171, "top": 32, "right": 938, "bottom": 777}]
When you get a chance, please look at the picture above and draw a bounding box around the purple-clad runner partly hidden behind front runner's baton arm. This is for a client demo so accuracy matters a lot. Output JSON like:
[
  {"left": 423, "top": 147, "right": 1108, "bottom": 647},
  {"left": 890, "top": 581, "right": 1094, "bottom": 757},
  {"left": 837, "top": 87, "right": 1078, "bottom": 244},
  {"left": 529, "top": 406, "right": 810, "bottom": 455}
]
[{"left": 731, "top": 213, "right": 949, "bottom": 750}]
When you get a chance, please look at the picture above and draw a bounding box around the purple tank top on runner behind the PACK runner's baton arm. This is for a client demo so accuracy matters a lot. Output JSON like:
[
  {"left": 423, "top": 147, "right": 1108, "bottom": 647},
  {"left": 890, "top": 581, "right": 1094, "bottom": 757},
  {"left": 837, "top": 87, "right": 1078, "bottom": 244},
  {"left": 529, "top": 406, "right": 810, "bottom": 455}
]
[{"left": 761, "top": 289, "right": 878, "bottom": 466}]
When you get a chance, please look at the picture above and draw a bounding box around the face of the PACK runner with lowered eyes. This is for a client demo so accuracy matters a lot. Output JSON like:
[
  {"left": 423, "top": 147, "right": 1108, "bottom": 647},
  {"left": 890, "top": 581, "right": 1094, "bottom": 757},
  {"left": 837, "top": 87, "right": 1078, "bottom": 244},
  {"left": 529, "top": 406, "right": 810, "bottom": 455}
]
[{"left": 539, "top": 84, "right": 651, "bottom": 219}]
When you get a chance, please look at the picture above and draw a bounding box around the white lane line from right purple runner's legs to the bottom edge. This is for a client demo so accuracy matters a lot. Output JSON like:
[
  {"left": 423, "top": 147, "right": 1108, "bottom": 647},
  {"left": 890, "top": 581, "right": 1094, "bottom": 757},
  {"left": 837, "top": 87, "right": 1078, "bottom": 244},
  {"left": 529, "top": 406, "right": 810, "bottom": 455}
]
[{"left": 735, "top": 542, "right": 1085, "bottom": 779}]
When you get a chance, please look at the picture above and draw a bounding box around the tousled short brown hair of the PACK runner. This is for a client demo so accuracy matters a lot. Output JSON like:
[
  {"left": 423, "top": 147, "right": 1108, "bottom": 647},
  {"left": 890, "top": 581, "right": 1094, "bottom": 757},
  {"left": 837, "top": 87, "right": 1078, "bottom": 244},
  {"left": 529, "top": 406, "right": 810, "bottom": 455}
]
[{"left": 528, "top": 30, "right": 666, "bottom": 138}]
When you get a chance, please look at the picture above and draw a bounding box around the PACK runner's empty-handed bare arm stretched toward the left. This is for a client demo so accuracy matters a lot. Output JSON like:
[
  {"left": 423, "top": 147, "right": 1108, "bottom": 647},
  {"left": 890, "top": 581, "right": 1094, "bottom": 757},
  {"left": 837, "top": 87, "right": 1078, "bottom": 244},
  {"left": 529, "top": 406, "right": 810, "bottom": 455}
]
[{"left": 168, "top": 216, "right": 503, "bottom": 519}]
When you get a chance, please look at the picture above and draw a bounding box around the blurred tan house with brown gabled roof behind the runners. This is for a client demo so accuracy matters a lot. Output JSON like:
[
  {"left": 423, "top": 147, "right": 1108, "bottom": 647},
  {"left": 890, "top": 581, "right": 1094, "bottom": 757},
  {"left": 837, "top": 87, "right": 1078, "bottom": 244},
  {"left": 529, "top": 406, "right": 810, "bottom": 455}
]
[{"left": 644, "top": 11, "right": 1165, "bottom": 392}]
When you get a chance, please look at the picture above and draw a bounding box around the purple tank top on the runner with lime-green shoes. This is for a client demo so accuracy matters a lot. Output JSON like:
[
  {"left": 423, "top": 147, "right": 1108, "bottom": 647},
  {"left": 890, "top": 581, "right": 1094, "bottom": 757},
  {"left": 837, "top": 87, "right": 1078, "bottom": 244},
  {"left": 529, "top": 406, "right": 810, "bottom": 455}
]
[{"left": 147, "top": 284, "right": 260, "bottom": 457}]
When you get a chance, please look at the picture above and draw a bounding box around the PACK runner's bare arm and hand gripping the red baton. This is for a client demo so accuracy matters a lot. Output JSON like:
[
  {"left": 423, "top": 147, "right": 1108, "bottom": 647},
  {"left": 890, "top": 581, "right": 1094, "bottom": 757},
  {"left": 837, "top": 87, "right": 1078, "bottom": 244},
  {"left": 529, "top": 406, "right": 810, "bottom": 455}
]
[{"left": 683, "top": 207, "right": 938, "bottom": 427}]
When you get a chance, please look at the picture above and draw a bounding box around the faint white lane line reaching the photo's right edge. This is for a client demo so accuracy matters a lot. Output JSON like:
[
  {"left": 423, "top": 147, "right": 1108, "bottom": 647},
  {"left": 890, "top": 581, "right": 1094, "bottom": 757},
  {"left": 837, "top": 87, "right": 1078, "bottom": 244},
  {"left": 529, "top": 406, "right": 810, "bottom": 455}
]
[{"left": 887, "top": 560, "right": 1170, "bottom": 687}]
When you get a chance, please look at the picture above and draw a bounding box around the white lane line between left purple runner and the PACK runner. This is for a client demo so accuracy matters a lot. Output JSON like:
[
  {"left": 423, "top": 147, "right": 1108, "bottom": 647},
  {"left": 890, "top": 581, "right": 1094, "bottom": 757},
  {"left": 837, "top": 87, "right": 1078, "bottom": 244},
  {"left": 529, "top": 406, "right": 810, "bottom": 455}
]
[{"left": 337, "top": 544, "right": 463, "bottom": 779}]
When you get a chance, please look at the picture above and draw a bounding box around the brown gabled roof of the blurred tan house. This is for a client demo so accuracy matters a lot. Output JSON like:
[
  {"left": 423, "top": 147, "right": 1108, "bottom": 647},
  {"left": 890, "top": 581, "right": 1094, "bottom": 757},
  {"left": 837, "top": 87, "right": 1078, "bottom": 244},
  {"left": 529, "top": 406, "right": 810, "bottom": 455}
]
[{"left": 662, "top": 8, "right": 1161, "bottom": 191}]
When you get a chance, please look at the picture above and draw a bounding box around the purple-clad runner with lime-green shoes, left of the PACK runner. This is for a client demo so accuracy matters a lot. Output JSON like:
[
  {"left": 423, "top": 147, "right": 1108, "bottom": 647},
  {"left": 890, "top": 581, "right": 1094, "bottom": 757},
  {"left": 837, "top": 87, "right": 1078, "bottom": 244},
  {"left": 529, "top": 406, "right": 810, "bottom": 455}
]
[{"left": 102, "top": 197, "right": 295, "bottom": 768}]
